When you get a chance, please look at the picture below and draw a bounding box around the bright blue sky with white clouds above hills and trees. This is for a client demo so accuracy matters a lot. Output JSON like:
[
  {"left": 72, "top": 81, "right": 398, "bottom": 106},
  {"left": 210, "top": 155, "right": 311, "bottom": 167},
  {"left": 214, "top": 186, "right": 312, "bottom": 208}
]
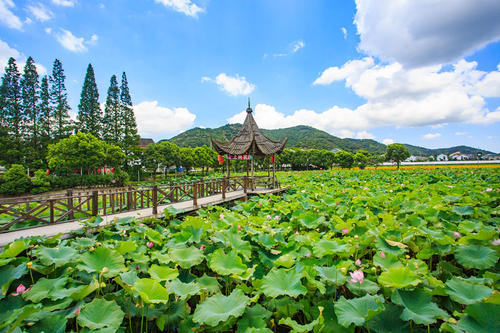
[{"left": 0, "top": 0, "right": 500, "bottom": 152}]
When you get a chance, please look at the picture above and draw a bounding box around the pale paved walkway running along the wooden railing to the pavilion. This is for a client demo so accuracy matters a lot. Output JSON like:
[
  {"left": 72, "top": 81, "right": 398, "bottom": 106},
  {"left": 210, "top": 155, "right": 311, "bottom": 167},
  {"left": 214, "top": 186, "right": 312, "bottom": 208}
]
[{"left": 0, "top": 190, "right": 246, "bottom": 247}]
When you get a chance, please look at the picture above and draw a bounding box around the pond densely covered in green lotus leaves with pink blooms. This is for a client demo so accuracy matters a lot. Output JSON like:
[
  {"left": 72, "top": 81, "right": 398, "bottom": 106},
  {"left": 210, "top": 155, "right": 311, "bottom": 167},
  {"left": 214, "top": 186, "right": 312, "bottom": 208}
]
[{"left": 0, "top": 169, "right": 500, "bottom": 332}]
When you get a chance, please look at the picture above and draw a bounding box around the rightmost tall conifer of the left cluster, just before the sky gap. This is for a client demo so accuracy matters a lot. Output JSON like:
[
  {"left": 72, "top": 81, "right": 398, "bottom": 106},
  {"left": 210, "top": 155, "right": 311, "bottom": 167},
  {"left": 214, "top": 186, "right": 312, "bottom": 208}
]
[{"left": 49, "top": 59, "right": 73, "bottom": 139}]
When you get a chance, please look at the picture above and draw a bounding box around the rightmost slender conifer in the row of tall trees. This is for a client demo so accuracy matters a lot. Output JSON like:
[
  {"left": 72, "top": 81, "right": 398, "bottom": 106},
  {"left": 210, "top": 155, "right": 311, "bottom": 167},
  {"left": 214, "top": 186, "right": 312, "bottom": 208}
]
[{"left": 120, "top": 72, "right": 139, "bottom": 156}]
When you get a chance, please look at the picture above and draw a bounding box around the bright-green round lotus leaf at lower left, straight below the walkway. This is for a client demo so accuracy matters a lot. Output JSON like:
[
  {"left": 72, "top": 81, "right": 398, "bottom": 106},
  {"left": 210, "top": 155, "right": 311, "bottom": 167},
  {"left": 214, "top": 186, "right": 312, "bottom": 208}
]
[{"left": 78, "top": 247, "right": 125, "bottom": 278}]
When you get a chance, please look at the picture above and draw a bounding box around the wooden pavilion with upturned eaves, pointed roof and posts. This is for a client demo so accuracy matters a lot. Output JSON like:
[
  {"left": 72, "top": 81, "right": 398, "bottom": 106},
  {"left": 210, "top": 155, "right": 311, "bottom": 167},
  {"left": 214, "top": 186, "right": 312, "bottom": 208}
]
[{"left": 211, "top": 99, "right": 288, "bottom": 189}]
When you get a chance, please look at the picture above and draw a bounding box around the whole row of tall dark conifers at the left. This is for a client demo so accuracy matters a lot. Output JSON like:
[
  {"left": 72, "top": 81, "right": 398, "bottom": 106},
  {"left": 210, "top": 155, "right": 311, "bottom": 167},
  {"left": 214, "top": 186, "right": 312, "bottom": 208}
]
[{"left": 0, "top": 57, "right": 139, "bottom": 170}]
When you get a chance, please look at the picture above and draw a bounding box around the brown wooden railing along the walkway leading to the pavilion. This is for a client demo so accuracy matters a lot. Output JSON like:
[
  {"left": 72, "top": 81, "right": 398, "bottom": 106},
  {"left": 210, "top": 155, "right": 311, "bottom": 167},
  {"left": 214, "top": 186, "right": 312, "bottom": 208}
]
[{"left": 0, "top": 176, "right": 279, "bottom": 232}]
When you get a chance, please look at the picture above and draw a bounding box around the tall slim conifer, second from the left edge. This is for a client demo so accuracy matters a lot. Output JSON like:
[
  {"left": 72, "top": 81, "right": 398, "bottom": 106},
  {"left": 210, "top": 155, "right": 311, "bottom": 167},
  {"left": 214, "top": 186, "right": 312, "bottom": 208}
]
[{"left": 21, "top": 57, "right": 42, "bottom": 163}]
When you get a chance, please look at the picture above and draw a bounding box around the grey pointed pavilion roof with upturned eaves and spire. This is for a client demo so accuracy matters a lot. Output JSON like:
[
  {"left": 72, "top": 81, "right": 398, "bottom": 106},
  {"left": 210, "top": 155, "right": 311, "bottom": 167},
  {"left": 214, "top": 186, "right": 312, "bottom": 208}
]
[{"left": 211, "top": 101, "right": 288, "bottom": 156}]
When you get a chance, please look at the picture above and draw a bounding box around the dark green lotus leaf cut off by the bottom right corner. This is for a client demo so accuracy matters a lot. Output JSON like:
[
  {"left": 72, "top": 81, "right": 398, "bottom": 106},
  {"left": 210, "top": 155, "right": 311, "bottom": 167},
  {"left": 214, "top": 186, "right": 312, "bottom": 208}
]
[{"left": 457, "top": 303, "right": 500, "bottom": 332}]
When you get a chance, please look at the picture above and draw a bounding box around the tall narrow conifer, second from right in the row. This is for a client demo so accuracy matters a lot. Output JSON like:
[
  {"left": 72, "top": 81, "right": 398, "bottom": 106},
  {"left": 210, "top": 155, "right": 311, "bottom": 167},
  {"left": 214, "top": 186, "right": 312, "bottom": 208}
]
[{"left": 103, "top": 75, "right": 123, "bottom": 146}]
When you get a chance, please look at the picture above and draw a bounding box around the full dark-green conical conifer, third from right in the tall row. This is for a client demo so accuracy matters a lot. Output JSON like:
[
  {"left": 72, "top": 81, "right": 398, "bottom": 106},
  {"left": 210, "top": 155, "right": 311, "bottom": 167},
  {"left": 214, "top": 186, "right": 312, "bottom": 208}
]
[{"left": 78, "top": 64, "right": 102, "bottom": 138}]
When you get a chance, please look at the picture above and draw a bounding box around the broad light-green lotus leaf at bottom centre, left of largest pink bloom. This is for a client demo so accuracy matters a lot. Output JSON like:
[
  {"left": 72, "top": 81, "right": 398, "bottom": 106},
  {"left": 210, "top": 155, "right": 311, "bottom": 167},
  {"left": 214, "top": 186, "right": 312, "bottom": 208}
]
[{"left": 262, "top": 269, "right": 307, "bottom": 297}]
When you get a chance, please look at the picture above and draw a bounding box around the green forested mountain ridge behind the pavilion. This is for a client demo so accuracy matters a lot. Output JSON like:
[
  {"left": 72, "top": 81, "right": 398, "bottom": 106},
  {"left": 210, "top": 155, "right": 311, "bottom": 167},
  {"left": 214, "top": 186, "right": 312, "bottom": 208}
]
[{"left": 164, "top": 124, "right": 491, "bottom": 156}]
